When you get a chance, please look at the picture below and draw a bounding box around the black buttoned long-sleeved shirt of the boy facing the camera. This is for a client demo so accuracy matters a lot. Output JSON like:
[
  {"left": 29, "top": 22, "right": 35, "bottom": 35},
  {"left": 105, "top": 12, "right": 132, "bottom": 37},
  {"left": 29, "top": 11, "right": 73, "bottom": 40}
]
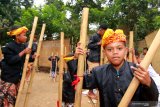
[{"left": 66, "top": 61, "right": 159, "bottom": 107}]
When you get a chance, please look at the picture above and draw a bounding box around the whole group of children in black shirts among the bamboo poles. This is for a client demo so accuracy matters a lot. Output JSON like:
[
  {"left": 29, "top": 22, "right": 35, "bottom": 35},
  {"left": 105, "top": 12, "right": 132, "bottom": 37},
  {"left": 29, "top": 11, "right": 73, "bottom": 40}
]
[{"left": 0, "top": 25, "right": 160, "bottom": 107}]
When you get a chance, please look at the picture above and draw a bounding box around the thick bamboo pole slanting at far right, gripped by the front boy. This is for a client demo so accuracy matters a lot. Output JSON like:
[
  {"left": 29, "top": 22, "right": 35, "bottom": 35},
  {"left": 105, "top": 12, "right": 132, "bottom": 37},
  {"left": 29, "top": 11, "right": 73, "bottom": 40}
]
[{"left": 118, "top": 29, "right": 160, "bottom": 107}]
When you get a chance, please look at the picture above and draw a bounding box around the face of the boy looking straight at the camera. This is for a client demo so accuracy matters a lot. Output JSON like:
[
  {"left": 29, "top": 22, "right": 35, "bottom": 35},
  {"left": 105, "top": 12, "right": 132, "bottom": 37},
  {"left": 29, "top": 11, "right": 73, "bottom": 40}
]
[{"left": 104, "top": 42, "right": 127, "bottom": 66}]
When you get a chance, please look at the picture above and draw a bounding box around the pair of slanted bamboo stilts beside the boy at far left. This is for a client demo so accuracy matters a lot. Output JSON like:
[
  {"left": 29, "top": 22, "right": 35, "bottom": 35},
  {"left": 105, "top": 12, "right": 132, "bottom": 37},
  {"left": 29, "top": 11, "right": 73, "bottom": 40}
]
[{"left": 15, "top": 17, "right": 46, "bottom": 107}]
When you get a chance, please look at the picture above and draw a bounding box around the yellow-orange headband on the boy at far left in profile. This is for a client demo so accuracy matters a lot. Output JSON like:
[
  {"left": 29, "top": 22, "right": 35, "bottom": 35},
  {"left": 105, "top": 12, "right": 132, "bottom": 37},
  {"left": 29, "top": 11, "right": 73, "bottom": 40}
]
[{"left": 7, "top": 26, "right": 28, "bottom": 36}]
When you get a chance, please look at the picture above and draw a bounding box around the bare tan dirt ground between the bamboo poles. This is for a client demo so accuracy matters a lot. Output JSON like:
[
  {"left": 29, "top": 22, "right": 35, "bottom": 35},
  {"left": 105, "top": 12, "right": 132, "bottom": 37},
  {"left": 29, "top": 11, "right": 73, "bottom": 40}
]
[{"left": 19, "top": 72, "right": 92, "bottom": 107}]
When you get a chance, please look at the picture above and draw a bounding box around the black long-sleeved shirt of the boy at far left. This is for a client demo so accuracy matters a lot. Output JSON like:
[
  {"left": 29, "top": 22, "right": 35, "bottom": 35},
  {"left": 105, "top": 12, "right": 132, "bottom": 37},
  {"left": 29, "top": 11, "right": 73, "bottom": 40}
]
[{"left": 1, "top": 41, "right": 26, "bottom": 83}]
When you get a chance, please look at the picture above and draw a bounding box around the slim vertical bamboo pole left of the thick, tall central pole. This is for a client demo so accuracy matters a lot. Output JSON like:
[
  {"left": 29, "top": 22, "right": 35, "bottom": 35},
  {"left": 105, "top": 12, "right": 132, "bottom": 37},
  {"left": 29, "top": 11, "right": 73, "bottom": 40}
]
[{"left": 57, "top": 32, "right": 64, "bottom": 107}]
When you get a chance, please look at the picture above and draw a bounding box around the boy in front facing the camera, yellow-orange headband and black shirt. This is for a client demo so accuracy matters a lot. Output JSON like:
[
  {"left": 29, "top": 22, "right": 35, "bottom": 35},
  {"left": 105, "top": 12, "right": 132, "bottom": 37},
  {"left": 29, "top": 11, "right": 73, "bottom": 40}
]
[{"left": 75, "top": 29, "right": 158, "bottom": 107}]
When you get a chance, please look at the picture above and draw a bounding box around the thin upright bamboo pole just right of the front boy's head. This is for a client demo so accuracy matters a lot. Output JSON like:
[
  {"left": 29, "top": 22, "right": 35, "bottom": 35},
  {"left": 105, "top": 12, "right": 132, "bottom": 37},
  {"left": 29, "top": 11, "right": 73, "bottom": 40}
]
[{"left": 129, "top": 31, "right": 134, "bottom": 62}]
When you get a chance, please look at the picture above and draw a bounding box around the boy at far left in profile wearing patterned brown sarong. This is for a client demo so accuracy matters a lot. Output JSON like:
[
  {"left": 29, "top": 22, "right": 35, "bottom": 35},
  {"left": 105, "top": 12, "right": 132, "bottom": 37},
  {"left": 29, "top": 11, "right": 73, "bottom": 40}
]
[{"left": 0, "top": 26, "right": 31, "bottom": 107}]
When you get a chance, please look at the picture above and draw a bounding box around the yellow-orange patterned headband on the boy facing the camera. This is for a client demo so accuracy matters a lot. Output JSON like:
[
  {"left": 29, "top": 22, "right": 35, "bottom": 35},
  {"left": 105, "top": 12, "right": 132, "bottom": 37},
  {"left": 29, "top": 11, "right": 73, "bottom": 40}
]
[{"left": 102, "top": 29, "right": 126, "bottom": 47}]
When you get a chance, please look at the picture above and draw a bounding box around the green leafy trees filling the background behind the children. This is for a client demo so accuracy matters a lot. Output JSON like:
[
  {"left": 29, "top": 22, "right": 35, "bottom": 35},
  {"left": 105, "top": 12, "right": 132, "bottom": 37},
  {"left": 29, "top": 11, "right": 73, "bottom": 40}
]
[{"left": 0, "top": 0, "right": 160, "bottom": 47}]
